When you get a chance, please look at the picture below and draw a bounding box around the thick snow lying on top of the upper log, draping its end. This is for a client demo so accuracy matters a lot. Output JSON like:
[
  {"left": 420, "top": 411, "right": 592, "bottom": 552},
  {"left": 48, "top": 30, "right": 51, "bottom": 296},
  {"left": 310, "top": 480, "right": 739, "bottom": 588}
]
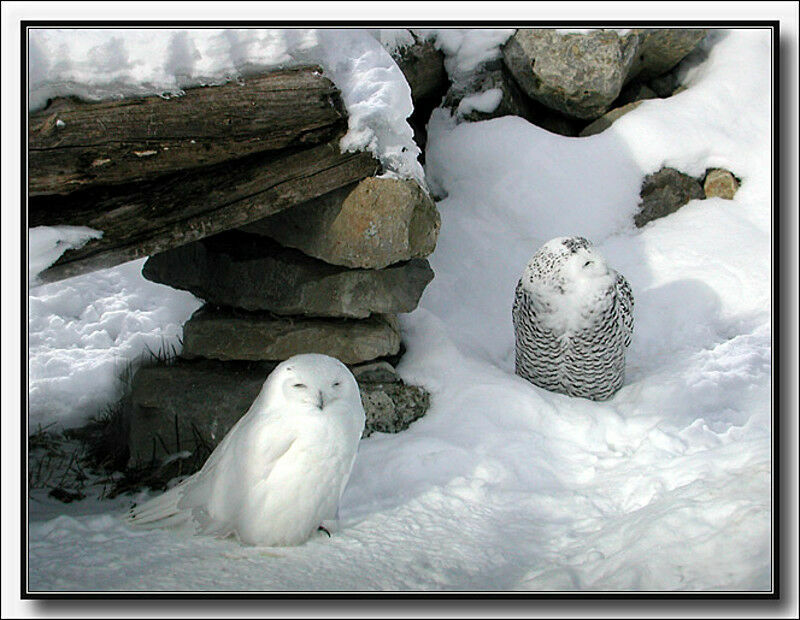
[{"left": 28, "top": 28, "right": 424, "bottom": 185}]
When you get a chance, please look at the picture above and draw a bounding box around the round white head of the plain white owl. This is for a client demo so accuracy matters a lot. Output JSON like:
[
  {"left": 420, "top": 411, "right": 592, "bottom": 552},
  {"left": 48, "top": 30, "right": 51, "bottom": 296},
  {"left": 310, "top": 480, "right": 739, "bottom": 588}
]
[{"left": 263, "top": 353, "right": 361, "bottom": 412}]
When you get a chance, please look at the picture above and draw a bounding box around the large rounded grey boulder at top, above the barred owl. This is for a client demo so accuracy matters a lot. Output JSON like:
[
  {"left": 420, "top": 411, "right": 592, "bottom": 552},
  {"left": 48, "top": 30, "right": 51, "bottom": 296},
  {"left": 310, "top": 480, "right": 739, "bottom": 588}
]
[{"left": 503, "top": 28, "right": 637, "bottom": 120}]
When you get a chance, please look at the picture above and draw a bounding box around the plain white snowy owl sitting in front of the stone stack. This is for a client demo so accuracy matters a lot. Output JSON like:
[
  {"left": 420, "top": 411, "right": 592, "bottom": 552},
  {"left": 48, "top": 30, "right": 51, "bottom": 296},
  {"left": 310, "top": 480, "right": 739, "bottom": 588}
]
[{"left": 128, "top": 353, "right": 365, "bottom": 546}]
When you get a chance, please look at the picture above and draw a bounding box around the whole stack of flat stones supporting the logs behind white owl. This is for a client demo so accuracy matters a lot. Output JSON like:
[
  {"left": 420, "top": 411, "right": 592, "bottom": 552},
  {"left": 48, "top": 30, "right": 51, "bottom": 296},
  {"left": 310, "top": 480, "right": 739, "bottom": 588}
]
[{"left": 134, "top": 178, "right": 440, "bottom": 461}]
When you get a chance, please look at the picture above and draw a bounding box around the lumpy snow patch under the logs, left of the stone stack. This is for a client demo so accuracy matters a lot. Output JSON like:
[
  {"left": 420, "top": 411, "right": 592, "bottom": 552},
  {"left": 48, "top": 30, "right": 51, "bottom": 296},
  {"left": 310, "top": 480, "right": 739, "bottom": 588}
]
[{"left": 28, "top": 260, "right": 202, "bottom": 431}]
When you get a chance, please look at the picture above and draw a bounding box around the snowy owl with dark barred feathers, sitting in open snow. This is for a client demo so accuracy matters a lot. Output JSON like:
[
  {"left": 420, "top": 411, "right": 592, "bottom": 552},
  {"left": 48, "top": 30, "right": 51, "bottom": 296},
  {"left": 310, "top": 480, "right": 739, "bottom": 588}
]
[{"left": 511, "top": 237, "right": 633, "bottom": 400}]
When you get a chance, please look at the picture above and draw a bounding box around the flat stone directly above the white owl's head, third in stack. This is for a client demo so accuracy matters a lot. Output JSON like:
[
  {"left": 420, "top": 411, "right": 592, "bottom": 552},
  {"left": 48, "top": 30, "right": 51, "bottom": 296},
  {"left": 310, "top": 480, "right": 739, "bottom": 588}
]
[{"left": 182, "top": 306, "right": 400, "bottom": 364}]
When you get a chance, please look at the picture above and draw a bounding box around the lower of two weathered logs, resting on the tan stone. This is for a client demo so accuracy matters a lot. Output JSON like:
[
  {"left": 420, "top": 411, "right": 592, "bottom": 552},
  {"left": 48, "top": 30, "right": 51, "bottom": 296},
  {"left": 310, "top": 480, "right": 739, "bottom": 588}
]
[{"left": 28, "top": 134, "right": 379, "bottom": 282}]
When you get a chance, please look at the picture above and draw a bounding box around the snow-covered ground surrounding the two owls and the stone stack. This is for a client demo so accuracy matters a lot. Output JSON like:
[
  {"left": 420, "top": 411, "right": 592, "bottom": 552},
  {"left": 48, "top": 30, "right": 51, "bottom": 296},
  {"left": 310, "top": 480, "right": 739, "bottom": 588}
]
[{"left": 23, "top": 30, "right": 774, "bottom": 591}]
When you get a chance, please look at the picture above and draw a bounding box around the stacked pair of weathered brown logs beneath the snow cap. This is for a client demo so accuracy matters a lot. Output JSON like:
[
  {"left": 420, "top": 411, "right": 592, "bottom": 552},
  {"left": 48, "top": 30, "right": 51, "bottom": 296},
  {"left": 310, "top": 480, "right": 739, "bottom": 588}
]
[{"left": 28, "top": 68, "right": 379, "bottom": 282}]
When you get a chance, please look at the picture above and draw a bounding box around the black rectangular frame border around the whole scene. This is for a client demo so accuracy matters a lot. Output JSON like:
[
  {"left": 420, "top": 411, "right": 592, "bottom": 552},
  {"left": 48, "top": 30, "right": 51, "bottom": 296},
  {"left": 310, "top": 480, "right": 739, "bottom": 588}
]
[{"left": 20, "top": 19, "right": 781, "bottom": 601}]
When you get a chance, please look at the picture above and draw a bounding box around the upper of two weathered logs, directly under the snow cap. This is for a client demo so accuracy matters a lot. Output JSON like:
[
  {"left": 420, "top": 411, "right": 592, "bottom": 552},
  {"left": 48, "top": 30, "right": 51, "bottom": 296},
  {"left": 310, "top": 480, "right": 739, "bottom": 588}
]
[{"left": 28, "top": 66, "right": 347, "bottom": 196}]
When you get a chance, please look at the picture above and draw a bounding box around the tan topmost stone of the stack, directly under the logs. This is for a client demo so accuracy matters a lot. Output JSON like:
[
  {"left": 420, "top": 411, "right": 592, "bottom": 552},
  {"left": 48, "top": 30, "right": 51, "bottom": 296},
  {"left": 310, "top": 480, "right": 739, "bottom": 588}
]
[{"left": 242, "top": 177, "right": 440, "bottom": 269}]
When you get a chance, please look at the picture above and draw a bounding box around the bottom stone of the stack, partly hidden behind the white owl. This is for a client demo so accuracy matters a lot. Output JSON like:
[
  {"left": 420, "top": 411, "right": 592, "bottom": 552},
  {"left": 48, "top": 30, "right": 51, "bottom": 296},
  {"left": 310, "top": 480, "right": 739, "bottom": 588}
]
[{"left": 127, "top": 359, "right": 430, "bottom": 462}]
